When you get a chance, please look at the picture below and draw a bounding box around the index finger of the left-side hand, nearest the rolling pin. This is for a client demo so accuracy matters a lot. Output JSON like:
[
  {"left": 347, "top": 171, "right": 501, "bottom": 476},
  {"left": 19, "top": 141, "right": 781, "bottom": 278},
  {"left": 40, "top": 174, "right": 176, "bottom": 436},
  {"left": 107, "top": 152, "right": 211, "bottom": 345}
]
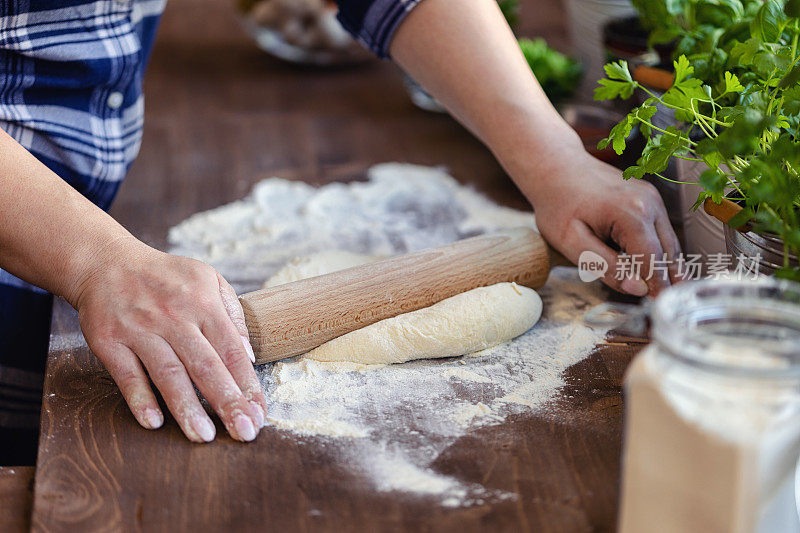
[{"left": 202, "top": 310, "right": 267, "bottom": 428}]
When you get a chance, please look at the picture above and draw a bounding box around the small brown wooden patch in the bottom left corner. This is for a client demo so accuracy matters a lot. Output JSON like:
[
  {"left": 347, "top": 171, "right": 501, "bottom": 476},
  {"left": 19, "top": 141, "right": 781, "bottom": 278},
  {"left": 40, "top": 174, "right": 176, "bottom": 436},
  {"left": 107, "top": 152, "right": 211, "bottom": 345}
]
[{"left": 0, "top": 466, "right": 35, "bottom": 533}]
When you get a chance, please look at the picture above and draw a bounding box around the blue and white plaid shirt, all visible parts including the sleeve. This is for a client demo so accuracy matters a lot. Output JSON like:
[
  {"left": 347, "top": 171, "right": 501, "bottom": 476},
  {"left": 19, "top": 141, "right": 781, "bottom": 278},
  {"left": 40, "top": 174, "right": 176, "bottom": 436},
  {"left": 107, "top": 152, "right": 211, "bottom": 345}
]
[{"left": 0, "top": 0, "right": 419, "bottom": 456}]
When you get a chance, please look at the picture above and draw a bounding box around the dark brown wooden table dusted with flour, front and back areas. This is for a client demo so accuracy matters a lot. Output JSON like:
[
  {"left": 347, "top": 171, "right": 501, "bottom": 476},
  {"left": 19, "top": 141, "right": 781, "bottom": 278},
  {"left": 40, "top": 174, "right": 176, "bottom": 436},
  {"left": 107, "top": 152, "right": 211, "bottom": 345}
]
[{"left": 32, "top": 0, "right": 640, "bottom": 532}]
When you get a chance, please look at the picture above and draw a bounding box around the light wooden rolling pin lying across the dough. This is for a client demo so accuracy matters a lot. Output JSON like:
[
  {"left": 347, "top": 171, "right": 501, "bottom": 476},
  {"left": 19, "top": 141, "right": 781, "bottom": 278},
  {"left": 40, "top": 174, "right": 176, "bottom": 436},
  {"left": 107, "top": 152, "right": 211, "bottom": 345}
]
[{"left": 239, "top": 228, "right": 568, "bottom": 364}]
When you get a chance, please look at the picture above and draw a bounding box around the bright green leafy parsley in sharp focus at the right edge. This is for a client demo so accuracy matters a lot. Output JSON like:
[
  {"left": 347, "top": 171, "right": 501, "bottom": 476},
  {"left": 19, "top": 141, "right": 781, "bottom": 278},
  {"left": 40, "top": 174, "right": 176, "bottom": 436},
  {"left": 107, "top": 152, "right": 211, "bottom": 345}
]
[{"left": 595, "top": 0, "right": 800, "bottom": 280}]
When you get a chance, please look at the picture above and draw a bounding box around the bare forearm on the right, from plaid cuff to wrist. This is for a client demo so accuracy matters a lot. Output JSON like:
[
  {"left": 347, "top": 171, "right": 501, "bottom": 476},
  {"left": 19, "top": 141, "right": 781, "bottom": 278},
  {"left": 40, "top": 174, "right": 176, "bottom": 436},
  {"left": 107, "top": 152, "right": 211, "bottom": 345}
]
[{"left": 390, "top": 0, "right": 583, "bottom": 194}]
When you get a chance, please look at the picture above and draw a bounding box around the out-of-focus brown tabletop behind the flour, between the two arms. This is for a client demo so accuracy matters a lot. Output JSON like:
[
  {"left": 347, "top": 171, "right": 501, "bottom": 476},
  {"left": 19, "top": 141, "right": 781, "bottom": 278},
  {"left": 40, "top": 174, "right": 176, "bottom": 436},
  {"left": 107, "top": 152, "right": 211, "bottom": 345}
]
[{"left": 111, "top": 0, "right": 569, "bottom": 243}]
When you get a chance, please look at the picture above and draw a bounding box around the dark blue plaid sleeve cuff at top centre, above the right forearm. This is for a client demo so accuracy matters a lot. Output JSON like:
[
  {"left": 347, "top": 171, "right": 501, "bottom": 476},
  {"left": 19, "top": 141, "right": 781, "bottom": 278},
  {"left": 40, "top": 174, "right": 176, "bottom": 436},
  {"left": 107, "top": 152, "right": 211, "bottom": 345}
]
[{"left": 336, "top": 0, "right": 421, "bottom": 58}]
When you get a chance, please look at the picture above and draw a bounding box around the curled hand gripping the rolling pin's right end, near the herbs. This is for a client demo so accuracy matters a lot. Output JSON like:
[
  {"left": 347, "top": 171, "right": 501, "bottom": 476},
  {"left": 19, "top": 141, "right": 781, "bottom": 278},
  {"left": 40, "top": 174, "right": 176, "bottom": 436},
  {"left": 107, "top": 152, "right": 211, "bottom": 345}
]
[{"left": 522, "top": 149, "right": 681, "bottom": 296}]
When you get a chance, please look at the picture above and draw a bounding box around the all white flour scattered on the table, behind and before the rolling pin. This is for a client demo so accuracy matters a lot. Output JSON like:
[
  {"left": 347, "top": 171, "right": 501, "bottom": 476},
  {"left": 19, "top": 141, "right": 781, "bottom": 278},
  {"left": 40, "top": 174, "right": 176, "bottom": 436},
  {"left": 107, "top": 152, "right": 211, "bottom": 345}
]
[{"left": 169, "top": 164, "right": 606, "bottom": 506}]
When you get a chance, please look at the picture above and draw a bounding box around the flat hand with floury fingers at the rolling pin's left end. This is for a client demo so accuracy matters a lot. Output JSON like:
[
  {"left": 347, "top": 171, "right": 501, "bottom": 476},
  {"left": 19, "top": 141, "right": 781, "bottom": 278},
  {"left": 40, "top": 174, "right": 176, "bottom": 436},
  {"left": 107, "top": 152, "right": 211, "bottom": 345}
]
[{"left": 70, "top": 237, "right": 267, "bottom": 442}]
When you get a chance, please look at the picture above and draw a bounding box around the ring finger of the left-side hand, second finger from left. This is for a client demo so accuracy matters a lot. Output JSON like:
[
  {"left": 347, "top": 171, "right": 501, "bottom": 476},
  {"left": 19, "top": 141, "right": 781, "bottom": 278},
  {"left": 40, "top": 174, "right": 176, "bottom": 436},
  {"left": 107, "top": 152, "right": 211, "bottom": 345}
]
[{"left": 131, "top": 336, "right": 217, "bottom": 442}]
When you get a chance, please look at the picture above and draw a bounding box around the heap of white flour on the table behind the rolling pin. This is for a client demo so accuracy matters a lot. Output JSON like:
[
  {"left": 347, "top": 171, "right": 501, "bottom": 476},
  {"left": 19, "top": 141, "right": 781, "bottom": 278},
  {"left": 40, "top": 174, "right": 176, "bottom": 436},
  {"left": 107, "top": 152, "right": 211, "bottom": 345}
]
[{"left": 168, "top": 163, "right": 535, "bottom": 290}]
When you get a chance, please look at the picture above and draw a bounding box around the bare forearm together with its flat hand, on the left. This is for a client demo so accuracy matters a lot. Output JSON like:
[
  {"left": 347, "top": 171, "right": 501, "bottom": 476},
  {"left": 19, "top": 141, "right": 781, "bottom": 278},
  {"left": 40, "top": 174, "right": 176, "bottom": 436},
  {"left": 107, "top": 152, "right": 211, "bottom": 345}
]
[{"left": 0, "top": 131, "right": 267, "bottom": 442}]
